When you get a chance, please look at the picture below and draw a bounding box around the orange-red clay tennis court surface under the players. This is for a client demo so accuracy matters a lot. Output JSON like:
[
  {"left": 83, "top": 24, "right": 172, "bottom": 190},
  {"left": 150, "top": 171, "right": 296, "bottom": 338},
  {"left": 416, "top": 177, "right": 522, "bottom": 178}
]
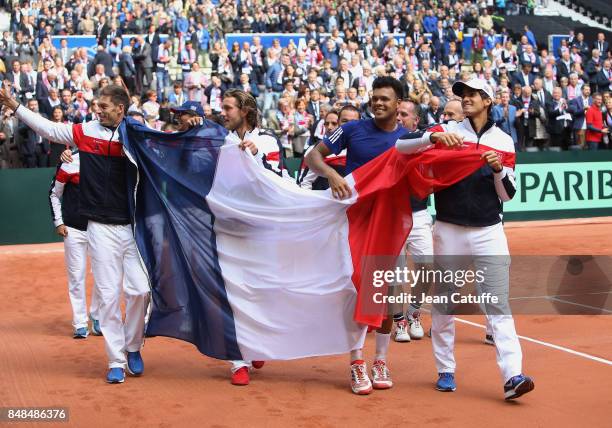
[{"left": 0, "top": 219, "right": 612, "bottom": 427}]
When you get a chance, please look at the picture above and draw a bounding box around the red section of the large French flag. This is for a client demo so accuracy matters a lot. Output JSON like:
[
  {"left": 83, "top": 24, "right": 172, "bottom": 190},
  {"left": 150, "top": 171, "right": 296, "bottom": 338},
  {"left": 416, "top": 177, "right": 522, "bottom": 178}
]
[{"left": 347, "top": 143, "right": 516, "bottom": 327}]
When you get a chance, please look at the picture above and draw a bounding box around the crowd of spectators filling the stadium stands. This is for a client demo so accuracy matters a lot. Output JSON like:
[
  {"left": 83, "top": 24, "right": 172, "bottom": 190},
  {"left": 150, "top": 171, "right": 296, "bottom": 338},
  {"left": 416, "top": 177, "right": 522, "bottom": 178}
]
[{"left": 0, "top": 0, "right": 612, "bottom": 168}]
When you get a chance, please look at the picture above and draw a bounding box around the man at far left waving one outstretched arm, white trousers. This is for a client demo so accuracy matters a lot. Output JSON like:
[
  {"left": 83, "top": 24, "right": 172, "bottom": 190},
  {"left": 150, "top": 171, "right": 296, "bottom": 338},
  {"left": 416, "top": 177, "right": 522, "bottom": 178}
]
[{"left": 0, "top": 85, "right": 149, "bottom": 383}]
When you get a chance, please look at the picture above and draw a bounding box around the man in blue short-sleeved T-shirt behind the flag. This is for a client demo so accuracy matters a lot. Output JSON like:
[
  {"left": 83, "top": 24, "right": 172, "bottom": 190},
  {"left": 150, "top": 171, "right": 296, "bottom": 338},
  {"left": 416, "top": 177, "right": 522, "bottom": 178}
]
[{"left": 306, "top": 76, "right": 406, "bottom": 394}]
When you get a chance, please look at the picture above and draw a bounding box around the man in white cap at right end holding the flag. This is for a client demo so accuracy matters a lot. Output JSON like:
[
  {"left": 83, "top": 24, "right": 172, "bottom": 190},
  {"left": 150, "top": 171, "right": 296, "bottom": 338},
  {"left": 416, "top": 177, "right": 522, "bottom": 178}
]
[{"left": 396, "top": 79, "right": 534, "bottom": 400}]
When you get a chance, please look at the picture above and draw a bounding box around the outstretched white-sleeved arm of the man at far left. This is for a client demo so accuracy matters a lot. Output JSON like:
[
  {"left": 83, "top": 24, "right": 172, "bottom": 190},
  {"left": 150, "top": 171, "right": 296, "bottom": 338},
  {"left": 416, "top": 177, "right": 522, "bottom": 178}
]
[{"left": 0, "top": 88, "right": 74, "bottom": 146}]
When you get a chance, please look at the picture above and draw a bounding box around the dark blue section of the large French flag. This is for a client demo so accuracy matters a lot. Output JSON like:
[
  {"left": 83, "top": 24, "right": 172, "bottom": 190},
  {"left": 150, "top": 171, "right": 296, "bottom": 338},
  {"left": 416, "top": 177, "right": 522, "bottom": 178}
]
[{"left": 119, "top": 119, "right": 242, "bottom": 360}]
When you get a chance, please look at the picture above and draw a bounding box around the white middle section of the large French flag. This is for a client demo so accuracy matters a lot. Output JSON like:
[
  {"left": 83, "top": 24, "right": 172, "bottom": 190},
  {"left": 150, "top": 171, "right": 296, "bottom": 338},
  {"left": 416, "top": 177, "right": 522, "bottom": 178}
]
[{"left": 206, "top": 145, "right": 366, "bottom": 360}]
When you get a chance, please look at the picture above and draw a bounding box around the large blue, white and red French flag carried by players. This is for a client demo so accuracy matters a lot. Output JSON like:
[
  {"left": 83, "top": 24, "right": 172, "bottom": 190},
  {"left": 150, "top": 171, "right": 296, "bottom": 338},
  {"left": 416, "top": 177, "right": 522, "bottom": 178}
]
[{"left": 119, "top": 120, "right": 512, "bottom": 360}]
